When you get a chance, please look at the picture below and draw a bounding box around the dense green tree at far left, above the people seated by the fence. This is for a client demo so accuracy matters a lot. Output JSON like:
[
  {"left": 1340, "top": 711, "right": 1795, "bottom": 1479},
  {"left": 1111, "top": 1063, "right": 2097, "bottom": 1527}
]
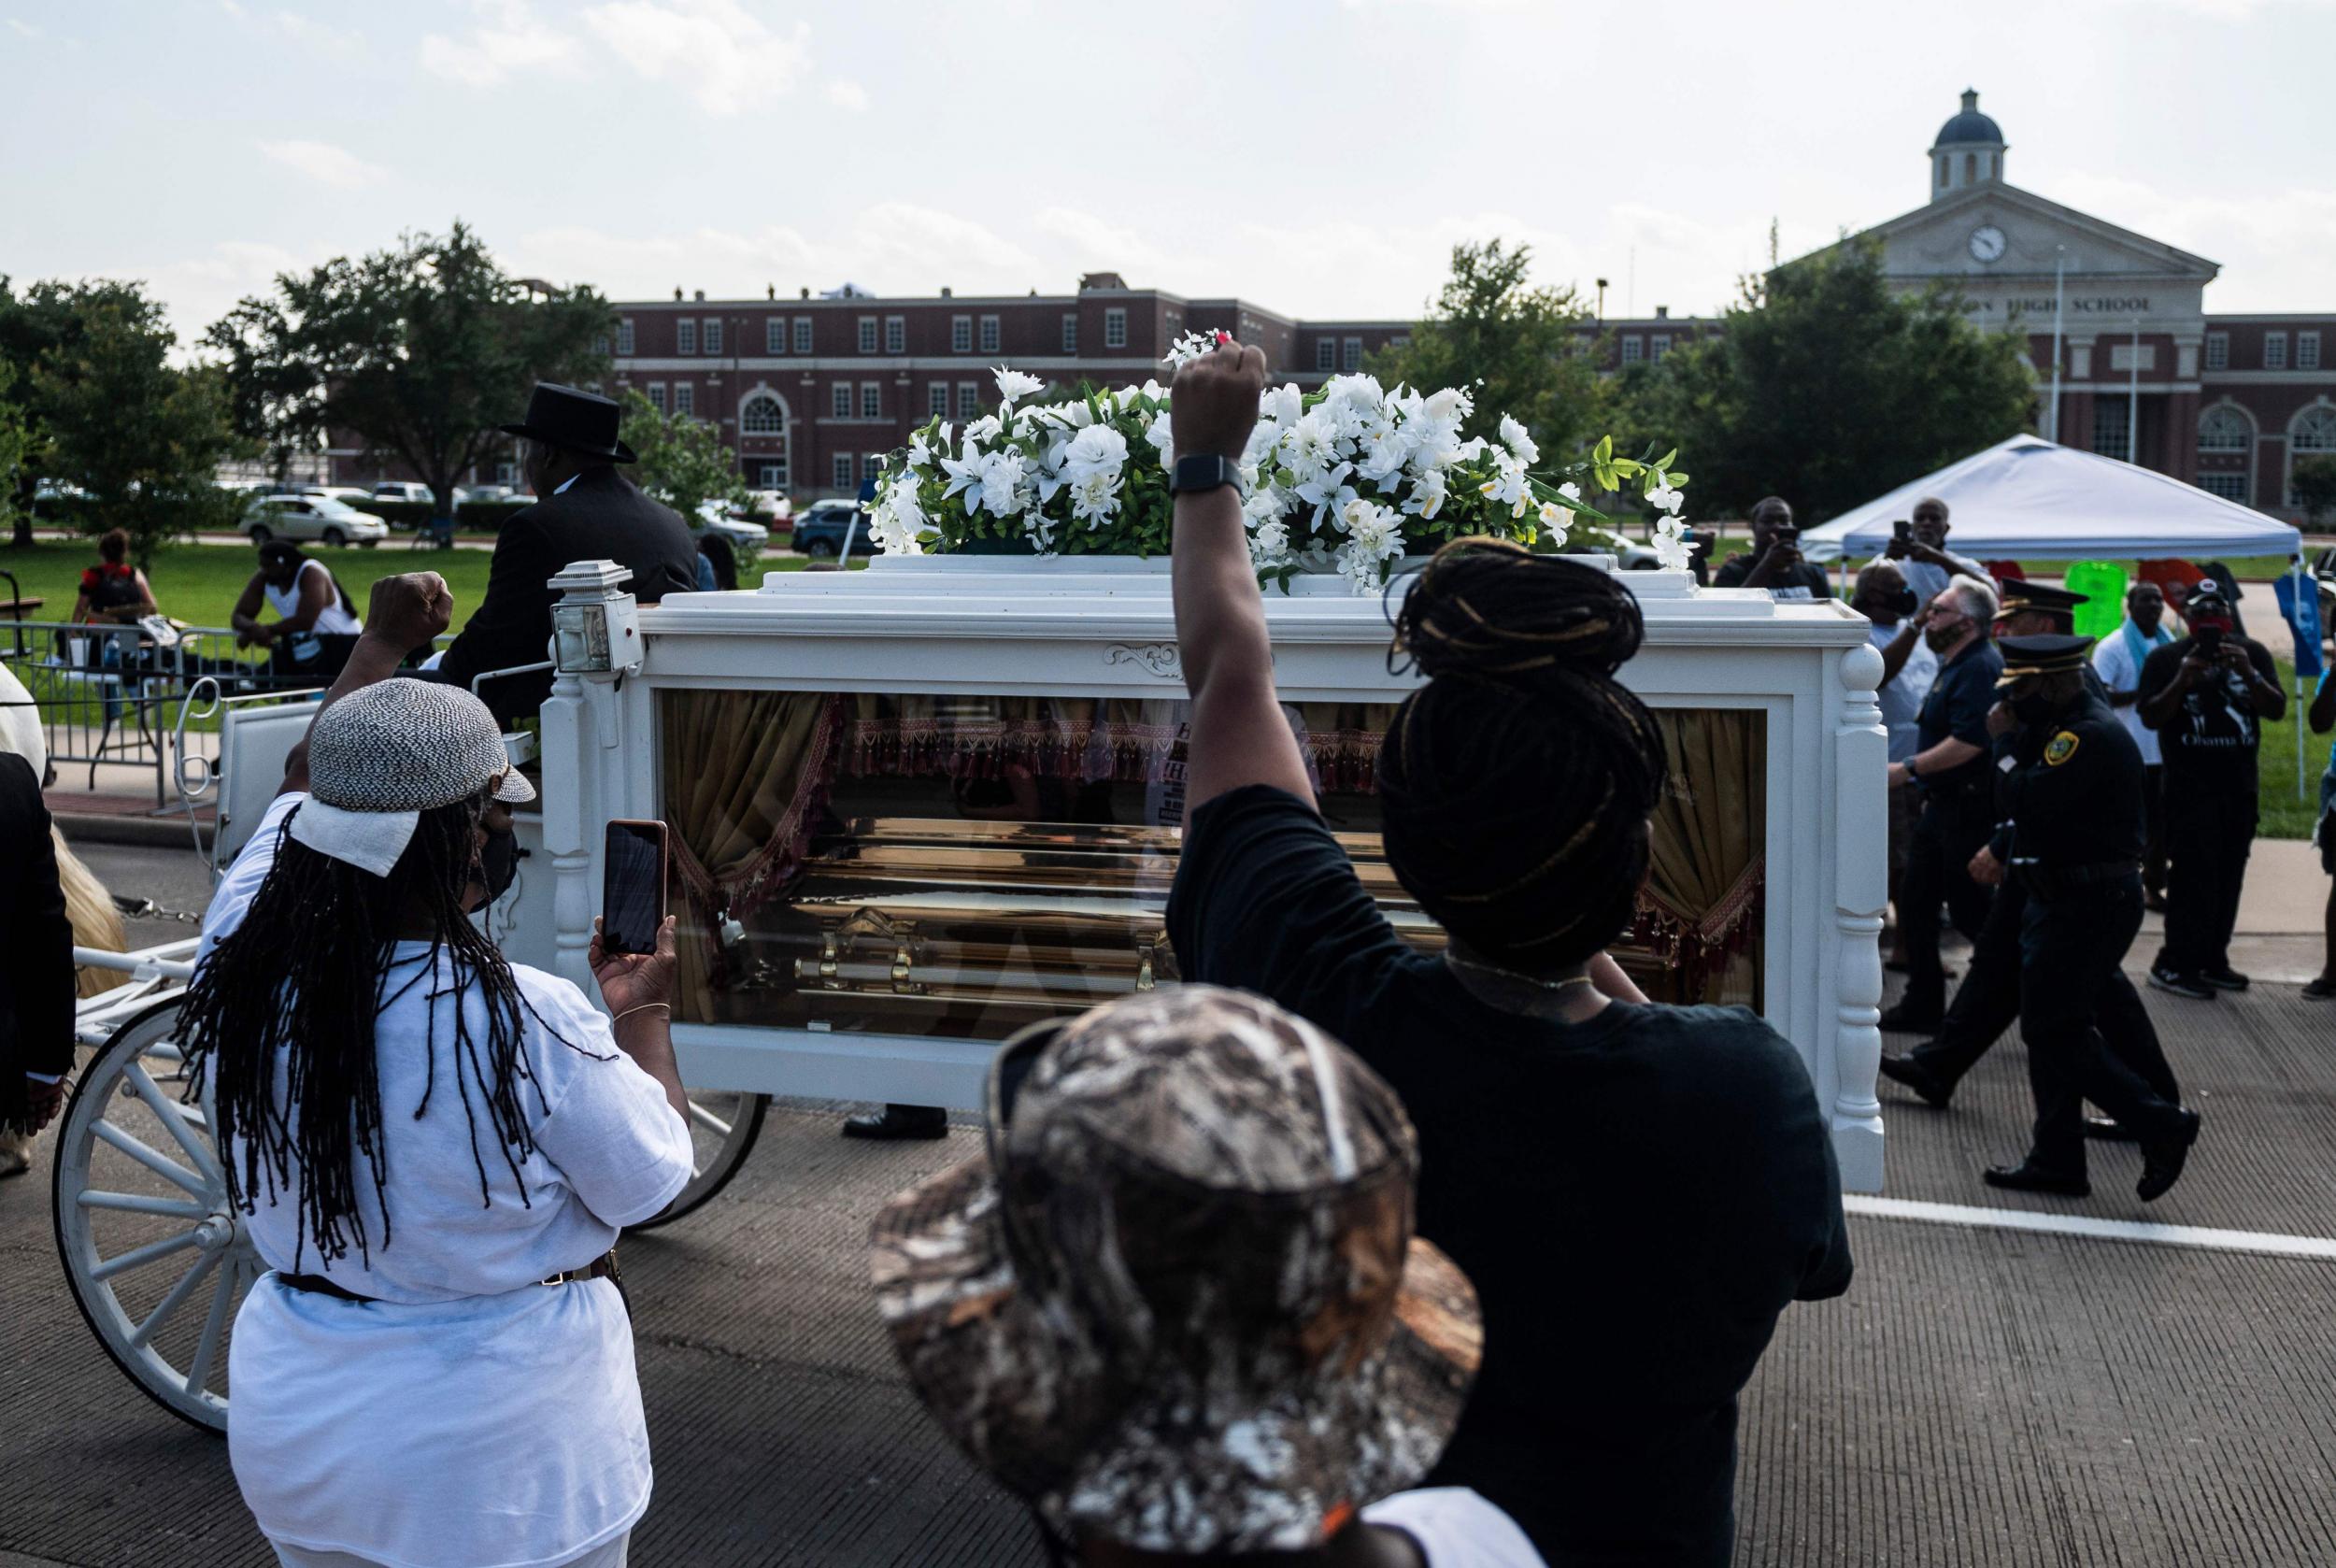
[{"left": 28, "top": 285, "right": 250, "bottom": 565}]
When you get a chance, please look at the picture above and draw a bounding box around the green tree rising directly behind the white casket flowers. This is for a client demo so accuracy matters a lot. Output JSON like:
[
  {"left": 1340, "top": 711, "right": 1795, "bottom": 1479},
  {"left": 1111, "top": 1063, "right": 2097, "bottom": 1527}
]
[{"left": 1369, "top": 238, "right": 1607, "bottom": 467}]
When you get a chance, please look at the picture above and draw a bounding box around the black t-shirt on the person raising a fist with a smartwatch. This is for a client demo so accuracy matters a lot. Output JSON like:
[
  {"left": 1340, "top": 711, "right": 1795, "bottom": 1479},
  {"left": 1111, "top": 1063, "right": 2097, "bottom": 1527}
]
[{"left": 1168, "top": 785, "right": 1850, "bottom": 1568}]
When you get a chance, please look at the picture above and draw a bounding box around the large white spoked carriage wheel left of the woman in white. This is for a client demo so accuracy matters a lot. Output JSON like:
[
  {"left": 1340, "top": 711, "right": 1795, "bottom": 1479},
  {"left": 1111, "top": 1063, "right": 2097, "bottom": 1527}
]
[{"left": 50, "top": 995, "right": 253, "bottom": 1433}]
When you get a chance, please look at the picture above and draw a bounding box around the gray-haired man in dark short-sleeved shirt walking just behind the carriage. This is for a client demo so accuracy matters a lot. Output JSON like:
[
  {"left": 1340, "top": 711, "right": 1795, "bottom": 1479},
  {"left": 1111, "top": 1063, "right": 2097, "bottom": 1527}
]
[{"left": 1881, "top": 577, "right": 2004, "bottom": 1033}]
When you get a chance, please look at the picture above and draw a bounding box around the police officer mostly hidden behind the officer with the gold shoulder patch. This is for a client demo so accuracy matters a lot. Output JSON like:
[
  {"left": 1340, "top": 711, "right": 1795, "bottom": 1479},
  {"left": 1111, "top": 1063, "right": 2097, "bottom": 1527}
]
[{"left": 1883, "top": 577, "right": 2182, "bottom": 1138}]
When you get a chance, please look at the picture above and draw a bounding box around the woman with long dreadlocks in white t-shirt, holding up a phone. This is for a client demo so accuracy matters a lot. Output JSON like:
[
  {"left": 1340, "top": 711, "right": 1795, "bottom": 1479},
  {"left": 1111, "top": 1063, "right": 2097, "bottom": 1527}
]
[{"left": 180, "top": 573, "right": 690, "bottom": 1568}]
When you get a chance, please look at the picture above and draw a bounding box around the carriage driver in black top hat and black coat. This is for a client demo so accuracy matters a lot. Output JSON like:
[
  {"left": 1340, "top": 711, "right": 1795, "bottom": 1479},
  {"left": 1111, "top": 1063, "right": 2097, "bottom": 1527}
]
[{"left": 437, "top": 381, "right": 699, "bottom": 729}]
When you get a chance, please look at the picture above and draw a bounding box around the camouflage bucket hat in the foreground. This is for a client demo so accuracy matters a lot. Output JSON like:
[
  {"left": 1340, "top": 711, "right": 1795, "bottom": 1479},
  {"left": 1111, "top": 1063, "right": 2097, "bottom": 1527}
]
[{"left": 872, "top": 986, "right": 1484, "bottom": 1551}]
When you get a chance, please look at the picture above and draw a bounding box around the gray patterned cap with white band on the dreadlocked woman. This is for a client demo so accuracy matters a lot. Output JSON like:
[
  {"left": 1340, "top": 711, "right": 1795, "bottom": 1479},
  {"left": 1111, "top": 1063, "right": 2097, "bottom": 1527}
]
[{"left": 290, "top": 680, "right": 535, "bottom": 877}]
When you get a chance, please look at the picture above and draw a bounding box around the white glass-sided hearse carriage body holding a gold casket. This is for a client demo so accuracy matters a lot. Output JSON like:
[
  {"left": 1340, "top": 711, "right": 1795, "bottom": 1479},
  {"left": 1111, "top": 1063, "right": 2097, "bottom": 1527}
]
[{"left": 498, "top": 556, "right": 1887, "bottom": 1191}]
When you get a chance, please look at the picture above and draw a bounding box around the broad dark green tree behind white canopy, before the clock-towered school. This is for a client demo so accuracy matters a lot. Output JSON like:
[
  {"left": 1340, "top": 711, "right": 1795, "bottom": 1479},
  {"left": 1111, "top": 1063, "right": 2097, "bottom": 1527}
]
[{"left": 1621, "top": 241, "right": 2035, "bottom": 523}]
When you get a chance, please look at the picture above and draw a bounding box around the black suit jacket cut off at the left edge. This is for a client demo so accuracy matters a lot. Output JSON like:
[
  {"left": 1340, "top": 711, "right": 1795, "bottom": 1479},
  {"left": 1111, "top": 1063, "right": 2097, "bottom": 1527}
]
[{"left": 0, "top": 752, "right": 75, "bottom": 1124}]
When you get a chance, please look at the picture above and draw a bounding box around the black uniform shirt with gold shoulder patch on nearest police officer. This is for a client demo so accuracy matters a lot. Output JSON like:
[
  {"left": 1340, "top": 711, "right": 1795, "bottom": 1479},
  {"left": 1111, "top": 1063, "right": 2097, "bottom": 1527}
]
[{"left": 2007, "top": 694, "right": 2147, "bottom": 869}]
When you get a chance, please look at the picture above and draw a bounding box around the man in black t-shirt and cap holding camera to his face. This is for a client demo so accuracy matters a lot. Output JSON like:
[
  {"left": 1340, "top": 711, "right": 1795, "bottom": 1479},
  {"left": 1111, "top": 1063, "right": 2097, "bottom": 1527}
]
[{"left": 2138, "top": 579, "right": 2287, "bottom": 1003}]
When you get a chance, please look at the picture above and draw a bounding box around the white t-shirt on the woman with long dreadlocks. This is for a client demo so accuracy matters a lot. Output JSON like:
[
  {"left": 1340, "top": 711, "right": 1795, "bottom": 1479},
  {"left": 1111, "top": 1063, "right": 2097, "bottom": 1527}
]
[{"left": 201, "top": 794, "right": 690, "bottom": 1568}]
